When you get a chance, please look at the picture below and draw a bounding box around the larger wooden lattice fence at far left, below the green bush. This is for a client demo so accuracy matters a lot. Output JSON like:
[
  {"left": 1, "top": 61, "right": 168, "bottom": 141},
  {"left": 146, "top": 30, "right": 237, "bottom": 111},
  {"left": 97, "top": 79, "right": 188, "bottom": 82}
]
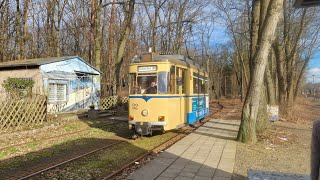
[{"left": 0, "top": 95, "right": 47, "bottom": 131}]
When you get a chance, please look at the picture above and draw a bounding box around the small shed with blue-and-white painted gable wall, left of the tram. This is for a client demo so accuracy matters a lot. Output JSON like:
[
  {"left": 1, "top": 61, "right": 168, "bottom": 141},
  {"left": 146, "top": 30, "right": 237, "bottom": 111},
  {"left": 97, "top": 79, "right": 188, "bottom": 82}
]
[{"left": 0, "top": 56, "right": 101, "bottom": 112}]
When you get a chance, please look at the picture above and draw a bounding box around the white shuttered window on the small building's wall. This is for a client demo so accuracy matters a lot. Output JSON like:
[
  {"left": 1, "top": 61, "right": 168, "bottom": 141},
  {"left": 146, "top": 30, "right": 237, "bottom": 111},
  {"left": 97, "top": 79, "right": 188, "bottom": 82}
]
[{"left": 48, "top": 83, "right": 67, "bottom": 103}]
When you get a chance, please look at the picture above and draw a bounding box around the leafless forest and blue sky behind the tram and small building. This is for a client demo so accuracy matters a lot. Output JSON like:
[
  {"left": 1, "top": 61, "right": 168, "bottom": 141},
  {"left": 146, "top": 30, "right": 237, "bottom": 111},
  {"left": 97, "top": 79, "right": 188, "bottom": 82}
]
[{"left": 0, "top": 0, "right": 320, "bottom": 142}]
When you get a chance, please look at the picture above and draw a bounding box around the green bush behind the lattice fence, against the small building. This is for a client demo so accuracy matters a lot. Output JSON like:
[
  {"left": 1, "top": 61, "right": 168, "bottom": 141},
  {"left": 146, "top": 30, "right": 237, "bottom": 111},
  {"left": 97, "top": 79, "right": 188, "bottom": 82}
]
[{"left": 2, "top": 78, "right": 35, "bottom": 97}]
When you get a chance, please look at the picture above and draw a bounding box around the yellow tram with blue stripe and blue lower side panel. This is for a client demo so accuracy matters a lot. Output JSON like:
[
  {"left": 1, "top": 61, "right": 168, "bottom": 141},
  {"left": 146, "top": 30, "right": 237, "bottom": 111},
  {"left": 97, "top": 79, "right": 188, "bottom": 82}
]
[{"left": 129, "top": 53, "right": 209, "bottom": 135}]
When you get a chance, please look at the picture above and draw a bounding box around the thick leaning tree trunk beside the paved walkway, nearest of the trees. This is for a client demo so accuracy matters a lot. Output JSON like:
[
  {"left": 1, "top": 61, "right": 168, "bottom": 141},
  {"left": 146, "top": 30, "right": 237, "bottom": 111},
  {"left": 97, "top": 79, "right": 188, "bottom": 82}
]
[{"left": 238, "top": 0, "right": 283, "bottom": 143}]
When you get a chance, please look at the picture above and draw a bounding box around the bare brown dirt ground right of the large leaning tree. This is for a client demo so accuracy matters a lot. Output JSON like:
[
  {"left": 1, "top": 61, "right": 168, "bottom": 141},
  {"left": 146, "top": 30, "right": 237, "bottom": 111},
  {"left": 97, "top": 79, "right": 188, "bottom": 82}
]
[{"left": 233, "top": 99, "right": 320, "bottom": 180}]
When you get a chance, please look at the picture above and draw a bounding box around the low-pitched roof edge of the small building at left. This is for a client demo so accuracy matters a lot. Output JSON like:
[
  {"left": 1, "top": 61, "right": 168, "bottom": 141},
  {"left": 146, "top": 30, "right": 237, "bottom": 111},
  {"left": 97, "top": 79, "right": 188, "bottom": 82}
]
[{"left": 0, "top": 56, "right": 101, "bottom": 73}]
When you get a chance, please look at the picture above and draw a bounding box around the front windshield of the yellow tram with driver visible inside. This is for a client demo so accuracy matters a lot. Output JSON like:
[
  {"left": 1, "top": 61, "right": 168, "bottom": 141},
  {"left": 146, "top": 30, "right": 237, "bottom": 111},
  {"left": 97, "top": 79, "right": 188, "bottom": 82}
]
[{"left": 130, "top": 72, "right": 168, "bottom": 94}]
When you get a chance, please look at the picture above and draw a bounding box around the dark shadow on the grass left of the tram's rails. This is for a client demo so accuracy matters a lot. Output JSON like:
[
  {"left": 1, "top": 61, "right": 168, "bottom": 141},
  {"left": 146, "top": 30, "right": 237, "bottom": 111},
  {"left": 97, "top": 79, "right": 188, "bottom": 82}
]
[{"left": 0, "top": 138, "right": 126, "bottom": 179}]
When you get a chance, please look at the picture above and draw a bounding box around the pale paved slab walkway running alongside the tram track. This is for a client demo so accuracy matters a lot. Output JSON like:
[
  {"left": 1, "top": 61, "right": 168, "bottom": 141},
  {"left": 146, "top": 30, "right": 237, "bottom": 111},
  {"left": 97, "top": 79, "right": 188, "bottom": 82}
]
[{"left": 129, "top": 119, "right": 240, "bottom": 180}]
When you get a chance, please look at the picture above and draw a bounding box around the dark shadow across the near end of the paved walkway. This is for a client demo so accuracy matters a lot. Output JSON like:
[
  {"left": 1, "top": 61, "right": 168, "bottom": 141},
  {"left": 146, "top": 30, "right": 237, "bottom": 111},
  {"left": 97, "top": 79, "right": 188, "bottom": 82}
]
[{"left": 127, "top": 152, "right": 246, "bottom": 180}]
